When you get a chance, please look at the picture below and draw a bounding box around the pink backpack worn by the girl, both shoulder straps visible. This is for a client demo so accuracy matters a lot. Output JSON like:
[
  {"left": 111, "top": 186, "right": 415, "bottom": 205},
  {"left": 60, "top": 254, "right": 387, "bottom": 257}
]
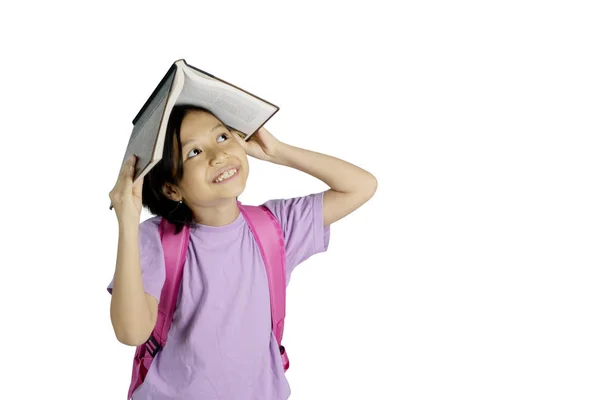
[{"left": 127, "top": 202, "right": 290, "bottom": 400}]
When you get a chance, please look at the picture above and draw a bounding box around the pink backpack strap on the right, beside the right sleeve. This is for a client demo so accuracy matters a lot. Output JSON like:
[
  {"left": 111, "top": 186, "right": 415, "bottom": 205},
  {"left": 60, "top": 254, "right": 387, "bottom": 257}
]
[{"left": 238, "top": 202, "right": 290, "bottom": 371}]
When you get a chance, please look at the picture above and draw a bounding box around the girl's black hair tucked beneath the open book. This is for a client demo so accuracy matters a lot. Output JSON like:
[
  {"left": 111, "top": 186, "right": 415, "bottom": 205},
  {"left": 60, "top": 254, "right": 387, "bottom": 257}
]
[{"left": 142, "top": 105, "right": 212, "bottom": 233}]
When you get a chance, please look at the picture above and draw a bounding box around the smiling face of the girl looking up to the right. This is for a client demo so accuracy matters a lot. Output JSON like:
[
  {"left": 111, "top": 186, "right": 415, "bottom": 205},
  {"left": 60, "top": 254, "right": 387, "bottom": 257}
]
[{"left": 169, "top": 110, "right": 248, "bottom": 207}]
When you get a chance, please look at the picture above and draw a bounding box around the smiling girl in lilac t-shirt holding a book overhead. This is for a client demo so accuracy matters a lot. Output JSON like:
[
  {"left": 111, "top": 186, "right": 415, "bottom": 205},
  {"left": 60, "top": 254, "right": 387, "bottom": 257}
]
[{"left": 108, "top": 106, "right": 377, "bottom": 400}]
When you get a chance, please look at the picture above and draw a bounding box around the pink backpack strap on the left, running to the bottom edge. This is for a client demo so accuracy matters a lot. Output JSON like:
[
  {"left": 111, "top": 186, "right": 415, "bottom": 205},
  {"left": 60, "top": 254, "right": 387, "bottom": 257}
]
[{"left": 127, "top": 218, "right": 190, "bottom": 400}]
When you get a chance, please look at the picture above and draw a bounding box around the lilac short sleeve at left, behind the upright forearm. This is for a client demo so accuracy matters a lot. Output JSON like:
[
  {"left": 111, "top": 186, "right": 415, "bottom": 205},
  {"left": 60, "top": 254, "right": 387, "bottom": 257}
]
[{"left": 107, "top": 217, "right": 165, "bottom": 301}]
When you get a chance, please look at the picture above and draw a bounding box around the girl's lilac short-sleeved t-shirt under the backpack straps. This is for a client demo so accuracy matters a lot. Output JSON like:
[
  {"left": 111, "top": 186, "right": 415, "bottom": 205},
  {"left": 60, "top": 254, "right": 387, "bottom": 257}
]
[{"left": 108, "top": 193, "right": 329, "bottom": 400}]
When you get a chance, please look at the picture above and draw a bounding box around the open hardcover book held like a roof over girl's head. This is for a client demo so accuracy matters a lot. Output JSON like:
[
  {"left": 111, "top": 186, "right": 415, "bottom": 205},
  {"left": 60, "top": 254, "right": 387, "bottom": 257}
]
[{"left": 121, "top": 60, "right": 279, "bottom": 188}]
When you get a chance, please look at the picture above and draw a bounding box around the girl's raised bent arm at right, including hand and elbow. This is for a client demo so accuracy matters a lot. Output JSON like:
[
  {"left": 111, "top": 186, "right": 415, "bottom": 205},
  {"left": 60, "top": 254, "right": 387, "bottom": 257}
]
[{"left": 234, "top": 128, "right": 377, "bottom": 225}]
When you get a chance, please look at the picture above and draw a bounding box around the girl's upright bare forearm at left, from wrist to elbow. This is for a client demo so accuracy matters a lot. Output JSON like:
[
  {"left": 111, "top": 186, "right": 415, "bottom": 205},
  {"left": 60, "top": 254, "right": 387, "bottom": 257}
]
[{"left": 110, "top": 224, "right": 153, "bottom": 345}]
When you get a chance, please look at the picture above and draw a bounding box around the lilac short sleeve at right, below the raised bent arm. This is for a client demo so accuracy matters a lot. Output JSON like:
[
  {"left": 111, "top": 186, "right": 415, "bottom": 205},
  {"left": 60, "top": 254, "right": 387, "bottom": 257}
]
[{"left": 265, "top": 192, "right": 330, "bottom": 281}]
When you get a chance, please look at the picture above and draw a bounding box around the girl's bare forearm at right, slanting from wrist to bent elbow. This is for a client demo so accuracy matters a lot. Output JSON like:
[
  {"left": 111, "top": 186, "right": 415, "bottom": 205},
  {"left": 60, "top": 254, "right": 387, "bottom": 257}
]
[{"left": 273, "top": 143, "right": 377, "bottom": 193}]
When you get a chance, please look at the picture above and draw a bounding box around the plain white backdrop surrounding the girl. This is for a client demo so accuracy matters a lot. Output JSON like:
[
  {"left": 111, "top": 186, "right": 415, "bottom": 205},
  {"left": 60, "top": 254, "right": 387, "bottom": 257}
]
[{"left": 0, "top": 0, "right": 600, "bottom": 400}]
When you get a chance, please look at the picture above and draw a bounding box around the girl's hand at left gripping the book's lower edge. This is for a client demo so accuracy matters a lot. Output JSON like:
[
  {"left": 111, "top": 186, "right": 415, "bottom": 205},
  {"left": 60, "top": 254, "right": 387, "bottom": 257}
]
[{"left": 108, "top": 155, "right": 144, "bottom": 226}]
